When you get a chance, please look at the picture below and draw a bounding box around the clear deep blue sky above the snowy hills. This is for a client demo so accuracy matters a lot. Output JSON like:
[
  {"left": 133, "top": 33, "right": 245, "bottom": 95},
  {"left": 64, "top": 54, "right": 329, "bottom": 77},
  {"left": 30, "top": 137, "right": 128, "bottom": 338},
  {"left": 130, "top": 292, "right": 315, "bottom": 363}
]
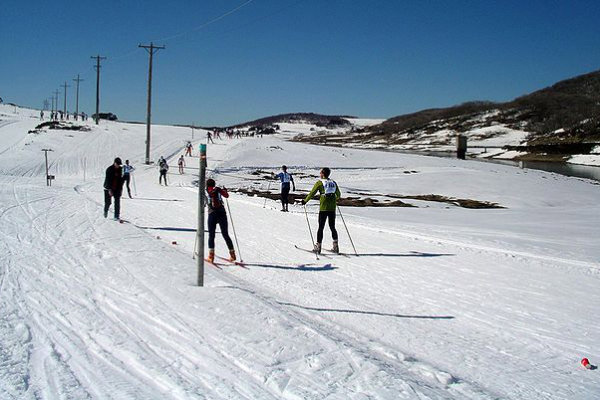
[{"left": 0, "top": 0, "right": 600, "bottom": 125}]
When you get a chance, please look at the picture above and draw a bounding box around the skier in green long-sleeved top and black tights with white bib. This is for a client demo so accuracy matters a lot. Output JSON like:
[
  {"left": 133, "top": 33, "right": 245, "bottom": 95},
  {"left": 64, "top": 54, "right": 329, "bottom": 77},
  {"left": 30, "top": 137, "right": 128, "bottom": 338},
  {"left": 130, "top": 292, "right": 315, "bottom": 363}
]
[{"left": 302, "top": 167, "right": 342, "bottom": 254}]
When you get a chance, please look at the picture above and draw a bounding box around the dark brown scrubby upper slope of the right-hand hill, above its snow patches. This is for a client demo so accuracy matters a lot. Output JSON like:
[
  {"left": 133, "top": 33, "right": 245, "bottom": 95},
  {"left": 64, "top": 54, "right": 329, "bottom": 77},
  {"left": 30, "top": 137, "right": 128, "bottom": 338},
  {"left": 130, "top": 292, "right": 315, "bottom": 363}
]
[{"left": 366, "top": 70, "right": 600, "bottom": 144}]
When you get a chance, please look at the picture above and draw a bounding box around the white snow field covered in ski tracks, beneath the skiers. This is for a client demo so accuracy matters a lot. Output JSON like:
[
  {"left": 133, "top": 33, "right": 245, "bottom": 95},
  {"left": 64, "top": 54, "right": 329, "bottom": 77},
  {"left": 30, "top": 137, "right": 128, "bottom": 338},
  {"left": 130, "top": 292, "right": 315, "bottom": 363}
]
[{"left": 0, "top": 104, "right": 600, "bottom": 399}]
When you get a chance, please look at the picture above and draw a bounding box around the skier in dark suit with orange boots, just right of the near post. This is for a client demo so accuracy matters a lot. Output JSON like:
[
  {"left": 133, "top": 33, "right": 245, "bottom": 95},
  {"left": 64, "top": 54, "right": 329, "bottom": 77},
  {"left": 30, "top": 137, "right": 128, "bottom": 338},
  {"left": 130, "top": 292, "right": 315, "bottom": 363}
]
[{"left": 206, "top": 179, "right": 236, "bottom": 262}]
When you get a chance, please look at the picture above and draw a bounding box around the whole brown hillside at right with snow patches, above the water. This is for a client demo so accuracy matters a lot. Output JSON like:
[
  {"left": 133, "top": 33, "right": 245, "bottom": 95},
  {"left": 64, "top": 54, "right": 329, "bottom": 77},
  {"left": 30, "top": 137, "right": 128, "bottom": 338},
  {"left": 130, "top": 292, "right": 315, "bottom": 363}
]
[{"left": 292, "top": 71, "right": 600, "bottom": 165}]
